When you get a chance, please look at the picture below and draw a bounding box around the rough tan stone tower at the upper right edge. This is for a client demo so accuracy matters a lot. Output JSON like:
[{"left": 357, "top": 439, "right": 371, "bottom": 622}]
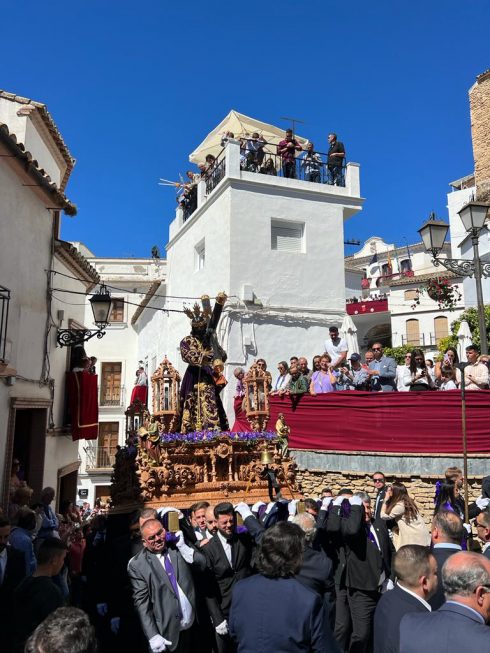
[{"left": 469, "top": 69, "right": 490, "bottom": 202}]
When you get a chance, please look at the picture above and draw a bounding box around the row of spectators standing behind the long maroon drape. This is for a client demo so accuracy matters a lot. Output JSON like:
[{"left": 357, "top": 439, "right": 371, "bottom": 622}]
[{"left": 234, "top": 326, "right": 489, "bottom": 401}]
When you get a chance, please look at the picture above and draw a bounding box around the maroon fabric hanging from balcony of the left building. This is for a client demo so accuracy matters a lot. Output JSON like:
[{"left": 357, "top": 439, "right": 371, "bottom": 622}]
[{"left": 66, "top": 372, "right": 99, "bottom": 440}]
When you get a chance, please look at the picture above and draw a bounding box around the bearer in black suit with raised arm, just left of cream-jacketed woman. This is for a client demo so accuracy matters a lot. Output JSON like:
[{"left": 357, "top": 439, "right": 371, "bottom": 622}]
[{"left": 328, "top": 492, "right": 392, "bottom": 653}]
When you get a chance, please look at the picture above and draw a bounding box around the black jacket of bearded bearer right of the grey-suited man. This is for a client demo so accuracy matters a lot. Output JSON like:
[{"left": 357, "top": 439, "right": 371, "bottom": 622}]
[{"left": 202, "top": 518, "right": 253, "bottom": 627}]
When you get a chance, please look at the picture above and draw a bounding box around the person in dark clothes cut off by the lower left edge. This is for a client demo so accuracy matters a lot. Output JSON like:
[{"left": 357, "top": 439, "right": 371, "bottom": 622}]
[{"left": 0, "top": 517, "right": 26, "bottom": 651}]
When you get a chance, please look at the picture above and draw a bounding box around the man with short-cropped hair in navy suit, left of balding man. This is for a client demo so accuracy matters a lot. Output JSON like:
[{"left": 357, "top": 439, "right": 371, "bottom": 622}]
[{"left": 374, "top": 544, "right": 437, "bottom": 653}]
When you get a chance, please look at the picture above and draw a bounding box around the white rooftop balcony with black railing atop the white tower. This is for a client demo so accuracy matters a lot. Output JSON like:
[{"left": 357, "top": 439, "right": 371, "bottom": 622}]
[{"left": 170, "top": 139, "right": 363, "bottom": 240}]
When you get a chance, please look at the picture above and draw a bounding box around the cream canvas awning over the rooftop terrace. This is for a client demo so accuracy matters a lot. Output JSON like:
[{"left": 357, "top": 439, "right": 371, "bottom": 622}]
[{"left": 189, "top": 110, "right": 308, "bottom": 163}]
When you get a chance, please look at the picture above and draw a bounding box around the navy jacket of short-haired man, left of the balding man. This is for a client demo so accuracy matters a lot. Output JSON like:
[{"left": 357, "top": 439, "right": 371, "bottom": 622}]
[{"left": 374, "top": 586, "right": 429, "bottom": 653}]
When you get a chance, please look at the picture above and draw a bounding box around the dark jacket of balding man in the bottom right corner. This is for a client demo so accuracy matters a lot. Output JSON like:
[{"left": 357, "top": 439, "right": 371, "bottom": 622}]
[{"left": 400, "top": 603, "right": 490, "bottom": 653}]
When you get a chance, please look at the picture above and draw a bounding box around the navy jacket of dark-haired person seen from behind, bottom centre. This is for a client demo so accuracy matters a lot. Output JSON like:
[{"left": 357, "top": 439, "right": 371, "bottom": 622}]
[{"left": 229, "top": 575, "right": 340, "bottom": 653}]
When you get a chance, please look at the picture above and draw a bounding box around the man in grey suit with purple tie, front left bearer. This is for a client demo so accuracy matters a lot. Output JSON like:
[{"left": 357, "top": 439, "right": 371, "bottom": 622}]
[{"left": 128, "top": 519, "right": 206, "bottom": 653}]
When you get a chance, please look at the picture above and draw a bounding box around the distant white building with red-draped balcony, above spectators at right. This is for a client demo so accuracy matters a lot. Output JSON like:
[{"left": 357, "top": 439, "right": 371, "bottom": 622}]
[{"left": 345, "top": 236, "right": 464, "bottom": 354}]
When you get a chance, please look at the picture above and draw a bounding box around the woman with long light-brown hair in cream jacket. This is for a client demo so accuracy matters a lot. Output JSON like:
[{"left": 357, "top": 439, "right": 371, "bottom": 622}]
[{"left": 380, "top": 482, "right": 430, "bottom": 551}]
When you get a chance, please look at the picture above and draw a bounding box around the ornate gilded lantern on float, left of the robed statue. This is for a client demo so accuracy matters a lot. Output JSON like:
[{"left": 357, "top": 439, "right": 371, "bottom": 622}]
[{"left": 151, "top": 356, "right": 180, "bottom": 433}]
